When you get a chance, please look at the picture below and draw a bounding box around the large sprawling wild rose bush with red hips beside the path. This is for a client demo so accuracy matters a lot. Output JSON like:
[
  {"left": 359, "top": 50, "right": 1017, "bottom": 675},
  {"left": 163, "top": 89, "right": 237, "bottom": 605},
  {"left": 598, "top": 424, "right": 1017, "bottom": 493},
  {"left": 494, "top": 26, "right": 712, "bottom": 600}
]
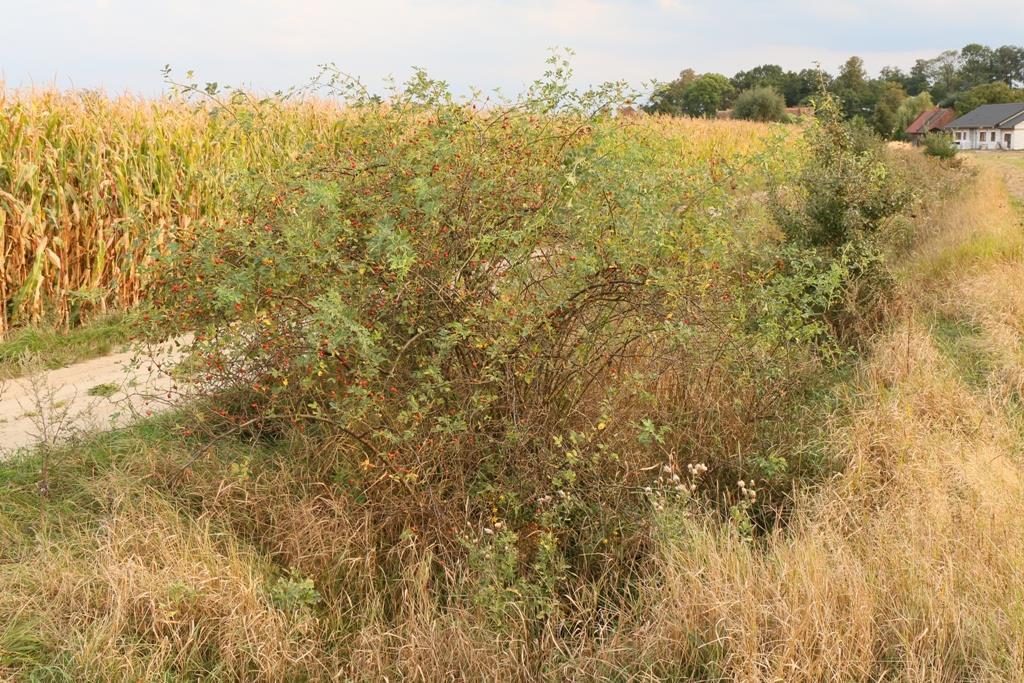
[{"left": 147, "top": 63, "right": 831, "bottom": 577}]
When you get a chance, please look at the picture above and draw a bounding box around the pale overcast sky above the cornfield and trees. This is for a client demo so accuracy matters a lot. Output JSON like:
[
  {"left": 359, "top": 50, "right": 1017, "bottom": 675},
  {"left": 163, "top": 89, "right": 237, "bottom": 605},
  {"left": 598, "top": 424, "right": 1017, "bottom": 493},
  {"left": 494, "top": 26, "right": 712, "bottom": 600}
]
[{"left": 0, "top": 0, "right": 1024, "bottom": 94}]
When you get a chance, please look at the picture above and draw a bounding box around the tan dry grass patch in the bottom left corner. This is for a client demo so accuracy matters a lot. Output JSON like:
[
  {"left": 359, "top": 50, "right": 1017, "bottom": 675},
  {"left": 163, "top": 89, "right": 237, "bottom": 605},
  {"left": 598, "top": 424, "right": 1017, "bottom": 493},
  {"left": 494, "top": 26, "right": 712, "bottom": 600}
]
[{"left": 4, "top": 499, "right": 314, "bottom": 680}]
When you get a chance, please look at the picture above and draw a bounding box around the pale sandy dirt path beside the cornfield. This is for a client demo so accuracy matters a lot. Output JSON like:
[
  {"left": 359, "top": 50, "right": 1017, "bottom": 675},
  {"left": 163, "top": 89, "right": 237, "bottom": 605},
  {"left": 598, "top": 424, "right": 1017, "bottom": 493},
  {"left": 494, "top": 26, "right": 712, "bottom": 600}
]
[{"left": 0, "top": 339, "right": 188, "bottom": 456}]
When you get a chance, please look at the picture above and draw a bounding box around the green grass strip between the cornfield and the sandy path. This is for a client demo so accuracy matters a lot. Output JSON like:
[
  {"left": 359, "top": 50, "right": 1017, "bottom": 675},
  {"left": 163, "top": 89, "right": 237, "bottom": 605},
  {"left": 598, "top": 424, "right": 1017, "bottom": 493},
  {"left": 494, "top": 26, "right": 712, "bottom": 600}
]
[{"left": 0, "top": 315, "right": 131, "bottom": 379}]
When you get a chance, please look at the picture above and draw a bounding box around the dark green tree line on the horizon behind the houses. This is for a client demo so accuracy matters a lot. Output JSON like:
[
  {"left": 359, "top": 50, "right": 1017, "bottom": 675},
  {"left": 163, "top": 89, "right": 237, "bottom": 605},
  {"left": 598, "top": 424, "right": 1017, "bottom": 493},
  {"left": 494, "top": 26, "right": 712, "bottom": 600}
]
[{"left": 645, "top": 43, "right": 1024, "bottom": 139}]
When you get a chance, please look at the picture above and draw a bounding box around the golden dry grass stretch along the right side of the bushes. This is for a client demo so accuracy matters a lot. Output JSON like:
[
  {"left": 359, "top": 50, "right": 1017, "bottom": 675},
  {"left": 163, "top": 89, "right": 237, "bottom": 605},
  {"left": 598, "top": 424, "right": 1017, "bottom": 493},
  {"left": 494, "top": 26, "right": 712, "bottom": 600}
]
[{"left": 622, "top": 161, "right": 1024, "bottom": 681}]
